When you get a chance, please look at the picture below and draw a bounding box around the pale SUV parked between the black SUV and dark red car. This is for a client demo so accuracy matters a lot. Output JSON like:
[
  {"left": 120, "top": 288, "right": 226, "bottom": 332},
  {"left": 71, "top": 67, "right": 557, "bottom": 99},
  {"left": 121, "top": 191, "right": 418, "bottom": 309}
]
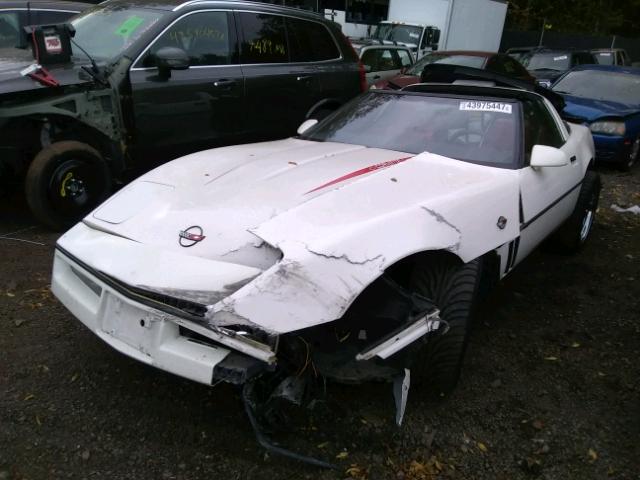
[{"left": 359, "top": 44, "right": 413, "bottom": 86}]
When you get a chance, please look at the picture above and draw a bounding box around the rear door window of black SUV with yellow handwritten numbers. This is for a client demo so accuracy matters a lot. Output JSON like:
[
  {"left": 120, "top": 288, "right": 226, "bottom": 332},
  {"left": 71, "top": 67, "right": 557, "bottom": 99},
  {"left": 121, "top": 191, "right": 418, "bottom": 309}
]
[{"left": 238, "top": 12, "right": 289, "bottom": 64}]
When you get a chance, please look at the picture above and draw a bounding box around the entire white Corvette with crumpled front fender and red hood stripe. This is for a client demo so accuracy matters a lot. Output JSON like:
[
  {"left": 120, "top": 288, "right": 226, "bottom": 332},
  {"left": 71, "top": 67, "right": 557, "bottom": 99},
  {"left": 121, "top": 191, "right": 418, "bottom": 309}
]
[{"left": 52, "top": 78, "right": 600, "bottom": 402}]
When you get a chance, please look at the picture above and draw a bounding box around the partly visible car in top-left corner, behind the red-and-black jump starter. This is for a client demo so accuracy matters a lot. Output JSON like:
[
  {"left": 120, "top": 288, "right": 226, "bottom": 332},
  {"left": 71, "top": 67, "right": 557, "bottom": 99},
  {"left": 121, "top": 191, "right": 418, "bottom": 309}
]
[{"left": 0, "top": 0, "right": 92, "bottom": 48}]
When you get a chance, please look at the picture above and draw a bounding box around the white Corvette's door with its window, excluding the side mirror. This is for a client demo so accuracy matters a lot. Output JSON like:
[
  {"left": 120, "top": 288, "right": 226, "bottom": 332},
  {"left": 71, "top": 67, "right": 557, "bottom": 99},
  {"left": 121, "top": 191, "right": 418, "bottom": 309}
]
[{"left": 515, "top": 99, "right": 583, "bottom": 263}]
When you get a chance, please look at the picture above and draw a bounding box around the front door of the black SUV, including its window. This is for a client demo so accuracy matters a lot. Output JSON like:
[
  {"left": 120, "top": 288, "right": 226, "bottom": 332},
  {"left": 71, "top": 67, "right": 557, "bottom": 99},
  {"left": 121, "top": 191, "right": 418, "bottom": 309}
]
[{"left": 130, "top": 10, "right": 244, "bottom": 162}]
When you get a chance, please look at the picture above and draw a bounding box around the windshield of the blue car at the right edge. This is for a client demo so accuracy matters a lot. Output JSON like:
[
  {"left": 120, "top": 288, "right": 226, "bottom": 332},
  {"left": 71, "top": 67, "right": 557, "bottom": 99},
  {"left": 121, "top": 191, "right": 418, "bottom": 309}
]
[{"left": 553, "top": 70, "right": 640, "bottom": 105}]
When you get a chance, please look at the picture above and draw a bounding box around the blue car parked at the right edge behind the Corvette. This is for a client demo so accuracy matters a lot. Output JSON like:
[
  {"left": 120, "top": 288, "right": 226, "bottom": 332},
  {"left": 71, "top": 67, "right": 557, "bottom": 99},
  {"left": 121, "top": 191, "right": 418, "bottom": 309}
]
[{"left": 553, "top": 65, "right": 640, "bottom": 170}]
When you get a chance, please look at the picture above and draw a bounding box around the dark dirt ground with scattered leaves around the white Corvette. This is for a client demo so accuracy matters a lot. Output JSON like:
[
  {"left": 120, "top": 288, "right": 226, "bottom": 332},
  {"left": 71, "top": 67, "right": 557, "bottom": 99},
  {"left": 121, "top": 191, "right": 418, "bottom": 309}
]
[{"left": 0, "top": 170, "right": 640, "bottom": 480}]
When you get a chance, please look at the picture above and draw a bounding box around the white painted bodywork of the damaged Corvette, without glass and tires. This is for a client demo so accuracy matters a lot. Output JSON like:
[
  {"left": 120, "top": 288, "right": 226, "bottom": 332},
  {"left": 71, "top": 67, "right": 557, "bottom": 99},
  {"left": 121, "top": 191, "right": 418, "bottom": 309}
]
[{"left": 52, "top": 90, "right": 594, "bottom": 383}]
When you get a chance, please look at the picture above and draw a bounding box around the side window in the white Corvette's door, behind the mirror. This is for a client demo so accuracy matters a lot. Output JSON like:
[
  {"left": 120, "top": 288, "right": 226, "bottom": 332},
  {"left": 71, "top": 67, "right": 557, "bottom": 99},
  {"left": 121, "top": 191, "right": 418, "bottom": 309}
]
[{"left": 522, "top": 100, "right": 564, "bottom": 165}]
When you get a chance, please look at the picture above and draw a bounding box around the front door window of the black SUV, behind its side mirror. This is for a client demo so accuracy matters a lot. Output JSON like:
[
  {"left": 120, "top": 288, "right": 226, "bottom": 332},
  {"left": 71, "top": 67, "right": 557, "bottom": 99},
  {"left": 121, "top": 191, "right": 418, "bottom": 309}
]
[{"left": 142, "top": 11, "right": 237, "bottom": 67}]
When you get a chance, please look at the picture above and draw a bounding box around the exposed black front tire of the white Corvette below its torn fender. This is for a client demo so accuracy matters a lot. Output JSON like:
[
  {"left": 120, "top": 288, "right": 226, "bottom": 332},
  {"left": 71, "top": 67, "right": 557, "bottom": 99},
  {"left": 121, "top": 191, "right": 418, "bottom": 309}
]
[{"left": 410, "top": 254, "right": 481, "bottom": 396}]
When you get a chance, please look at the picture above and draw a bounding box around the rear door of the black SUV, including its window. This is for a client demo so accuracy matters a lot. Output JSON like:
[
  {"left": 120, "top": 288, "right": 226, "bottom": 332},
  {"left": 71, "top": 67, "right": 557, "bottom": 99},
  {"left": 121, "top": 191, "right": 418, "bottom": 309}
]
[{"left": 236, "top": 12, "right": 320, "bottom": 140}]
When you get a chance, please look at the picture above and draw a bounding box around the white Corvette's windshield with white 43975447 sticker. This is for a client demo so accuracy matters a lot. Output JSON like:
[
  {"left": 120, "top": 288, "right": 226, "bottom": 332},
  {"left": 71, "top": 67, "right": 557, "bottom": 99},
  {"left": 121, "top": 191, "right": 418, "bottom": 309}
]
[{"left": 302, "top": 92, "right": 519, "bottom": 167}]
